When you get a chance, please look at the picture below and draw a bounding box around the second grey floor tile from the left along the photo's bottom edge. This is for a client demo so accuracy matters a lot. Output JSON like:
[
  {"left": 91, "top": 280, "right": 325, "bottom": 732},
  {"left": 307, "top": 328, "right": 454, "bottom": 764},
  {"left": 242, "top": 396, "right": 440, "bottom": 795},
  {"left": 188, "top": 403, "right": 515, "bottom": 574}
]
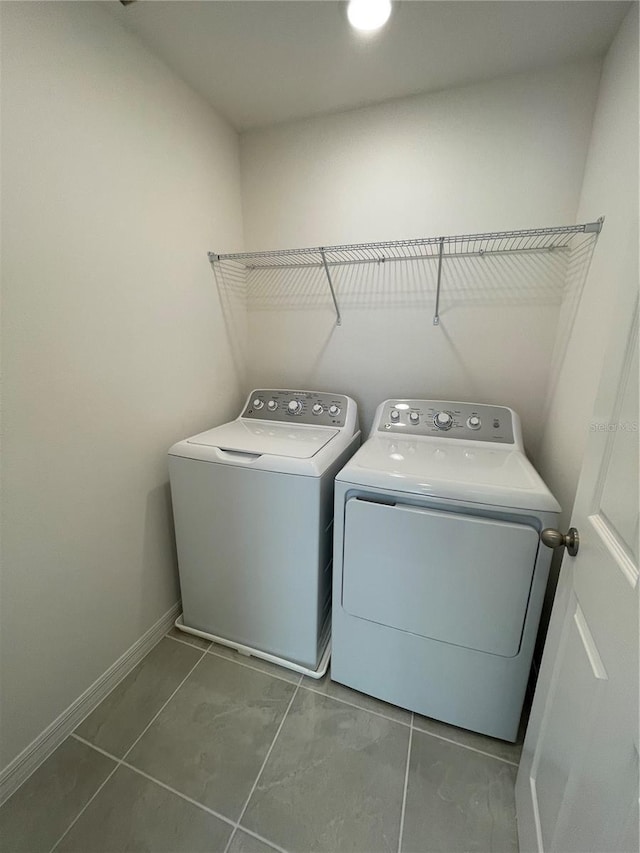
[{"left": 56, "top": 767, "right": 233, "bottom": 853}]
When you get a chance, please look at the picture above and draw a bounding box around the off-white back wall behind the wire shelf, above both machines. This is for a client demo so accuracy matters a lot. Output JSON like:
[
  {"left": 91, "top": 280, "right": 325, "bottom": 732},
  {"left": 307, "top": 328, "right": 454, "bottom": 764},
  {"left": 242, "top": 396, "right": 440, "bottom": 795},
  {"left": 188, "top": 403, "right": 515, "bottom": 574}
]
[{"left": 241, "top": 61, "right": 600, "bottom": 452}]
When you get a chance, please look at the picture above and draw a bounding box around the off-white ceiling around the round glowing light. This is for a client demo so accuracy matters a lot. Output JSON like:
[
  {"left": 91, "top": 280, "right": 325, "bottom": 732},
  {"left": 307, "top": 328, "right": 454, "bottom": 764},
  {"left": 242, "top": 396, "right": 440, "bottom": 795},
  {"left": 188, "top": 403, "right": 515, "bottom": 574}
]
[{"left": 106, "top": 0, "right": 630, "bottom": 131}]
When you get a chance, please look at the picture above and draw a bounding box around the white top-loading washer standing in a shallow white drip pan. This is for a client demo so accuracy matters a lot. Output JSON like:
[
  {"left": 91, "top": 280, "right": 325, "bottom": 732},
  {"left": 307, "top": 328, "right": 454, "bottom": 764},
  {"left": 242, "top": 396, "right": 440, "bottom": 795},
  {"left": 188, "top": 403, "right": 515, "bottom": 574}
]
[{"left": 169, "top": 389, "right": 360, "bottom": 678}]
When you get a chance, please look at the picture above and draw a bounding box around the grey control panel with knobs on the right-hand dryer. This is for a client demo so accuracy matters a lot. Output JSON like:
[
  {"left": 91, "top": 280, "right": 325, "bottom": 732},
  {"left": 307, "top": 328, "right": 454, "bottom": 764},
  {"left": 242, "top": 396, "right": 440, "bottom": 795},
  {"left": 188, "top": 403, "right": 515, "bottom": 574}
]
[{"left": 376, "top": 400, "right": 514, "bottom": 444}]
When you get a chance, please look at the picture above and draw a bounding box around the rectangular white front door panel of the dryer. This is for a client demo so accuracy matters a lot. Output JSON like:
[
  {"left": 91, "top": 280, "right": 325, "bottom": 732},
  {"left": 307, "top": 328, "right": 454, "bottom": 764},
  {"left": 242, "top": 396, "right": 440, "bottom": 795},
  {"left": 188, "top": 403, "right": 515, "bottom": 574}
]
[{"left": 342, "top": 498, "right": 539, "bottom": 657}]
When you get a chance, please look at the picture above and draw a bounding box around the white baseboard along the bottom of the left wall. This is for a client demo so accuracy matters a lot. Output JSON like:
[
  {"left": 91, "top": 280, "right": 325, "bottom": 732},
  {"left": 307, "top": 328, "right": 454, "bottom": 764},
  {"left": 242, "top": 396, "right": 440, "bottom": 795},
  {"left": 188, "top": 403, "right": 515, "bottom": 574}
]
[{"left": 0, "top": 601, "right": 182, "bottom": 805}]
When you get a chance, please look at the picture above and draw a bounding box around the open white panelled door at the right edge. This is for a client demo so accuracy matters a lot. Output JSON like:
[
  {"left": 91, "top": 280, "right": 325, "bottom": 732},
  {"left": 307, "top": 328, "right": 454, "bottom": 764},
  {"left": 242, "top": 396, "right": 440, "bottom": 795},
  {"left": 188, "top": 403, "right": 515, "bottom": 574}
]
[{"left": 516, "top": 256, "right": 638, "bottom": 853}]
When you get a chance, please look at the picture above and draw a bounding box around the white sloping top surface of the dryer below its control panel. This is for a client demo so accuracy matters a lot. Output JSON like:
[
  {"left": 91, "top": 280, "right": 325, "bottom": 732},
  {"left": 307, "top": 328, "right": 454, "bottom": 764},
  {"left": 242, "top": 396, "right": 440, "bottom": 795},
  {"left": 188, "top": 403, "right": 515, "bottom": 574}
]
[{"left": 337, "top": 435, "right": 560, "bottom": 512}]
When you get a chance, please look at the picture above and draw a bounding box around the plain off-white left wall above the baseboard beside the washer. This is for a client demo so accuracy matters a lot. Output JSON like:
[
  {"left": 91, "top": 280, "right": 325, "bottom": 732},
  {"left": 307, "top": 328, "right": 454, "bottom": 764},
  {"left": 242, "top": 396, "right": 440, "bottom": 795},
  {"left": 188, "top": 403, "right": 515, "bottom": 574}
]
[{"left": 1, "top": 2, "right": 242, "bottom": 766}]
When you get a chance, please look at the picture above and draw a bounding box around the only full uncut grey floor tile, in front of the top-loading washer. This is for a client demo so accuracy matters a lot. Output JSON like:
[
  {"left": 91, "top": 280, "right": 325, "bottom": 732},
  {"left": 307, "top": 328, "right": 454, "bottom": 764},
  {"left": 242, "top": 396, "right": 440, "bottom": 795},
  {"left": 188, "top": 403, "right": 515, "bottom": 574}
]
[{"left": 127, "top": 652, "right": 295, "bottom": 819}]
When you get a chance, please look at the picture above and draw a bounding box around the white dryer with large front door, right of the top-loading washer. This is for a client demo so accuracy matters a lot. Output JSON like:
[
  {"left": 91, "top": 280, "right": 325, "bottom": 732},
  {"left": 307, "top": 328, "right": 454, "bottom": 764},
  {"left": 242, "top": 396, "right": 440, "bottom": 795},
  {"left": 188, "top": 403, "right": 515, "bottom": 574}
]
[{"left": 331, "top": 400, "right": 560, "bottom": 741}]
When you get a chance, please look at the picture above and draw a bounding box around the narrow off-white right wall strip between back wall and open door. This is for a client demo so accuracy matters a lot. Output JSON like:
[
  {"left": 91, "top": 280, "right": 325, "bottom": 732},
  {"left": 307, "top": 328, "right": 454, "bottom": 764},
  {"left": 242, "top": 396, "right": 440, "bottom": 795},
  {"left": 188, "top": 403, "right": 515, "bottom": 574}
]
[{"left": 539, "top": 4, "right": 638, "bottom": 524}]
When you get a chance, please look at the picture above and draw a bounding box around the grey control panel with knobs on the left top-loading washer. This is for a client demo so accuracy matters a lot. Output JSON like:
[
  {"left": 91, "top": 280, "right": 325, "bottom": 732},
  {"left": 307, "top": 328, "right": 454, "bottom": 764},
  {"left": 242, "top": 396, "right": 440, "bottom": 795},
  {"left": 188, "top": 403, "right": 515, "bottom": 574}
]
[{"left": 241, "top": 388, "right": 349, "bottom": 427}]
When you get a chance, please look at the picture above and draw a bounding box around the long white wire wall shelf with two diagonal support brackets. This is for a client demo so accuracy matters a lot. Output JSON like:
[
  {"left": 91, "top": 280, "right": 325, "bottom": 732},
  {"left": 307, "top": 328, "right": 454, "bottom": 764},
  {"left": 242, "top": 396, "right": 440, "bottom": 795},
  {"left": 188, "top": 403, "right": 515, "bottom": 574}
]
[{"left": 208, "top": 216, "right": 604, "bottom": 326}]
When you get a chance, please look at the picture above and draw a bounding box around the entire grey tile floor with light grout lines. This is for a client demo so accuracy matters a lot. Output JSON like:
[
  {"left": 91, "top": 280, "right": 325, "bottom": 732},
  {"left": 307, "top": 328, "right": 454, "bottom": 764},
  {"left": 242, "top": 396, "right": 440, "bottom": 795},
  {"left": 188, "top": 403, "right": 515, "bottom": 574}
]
[{"left": 0, "top": 630, "right": 520, "bottom": 853}]
